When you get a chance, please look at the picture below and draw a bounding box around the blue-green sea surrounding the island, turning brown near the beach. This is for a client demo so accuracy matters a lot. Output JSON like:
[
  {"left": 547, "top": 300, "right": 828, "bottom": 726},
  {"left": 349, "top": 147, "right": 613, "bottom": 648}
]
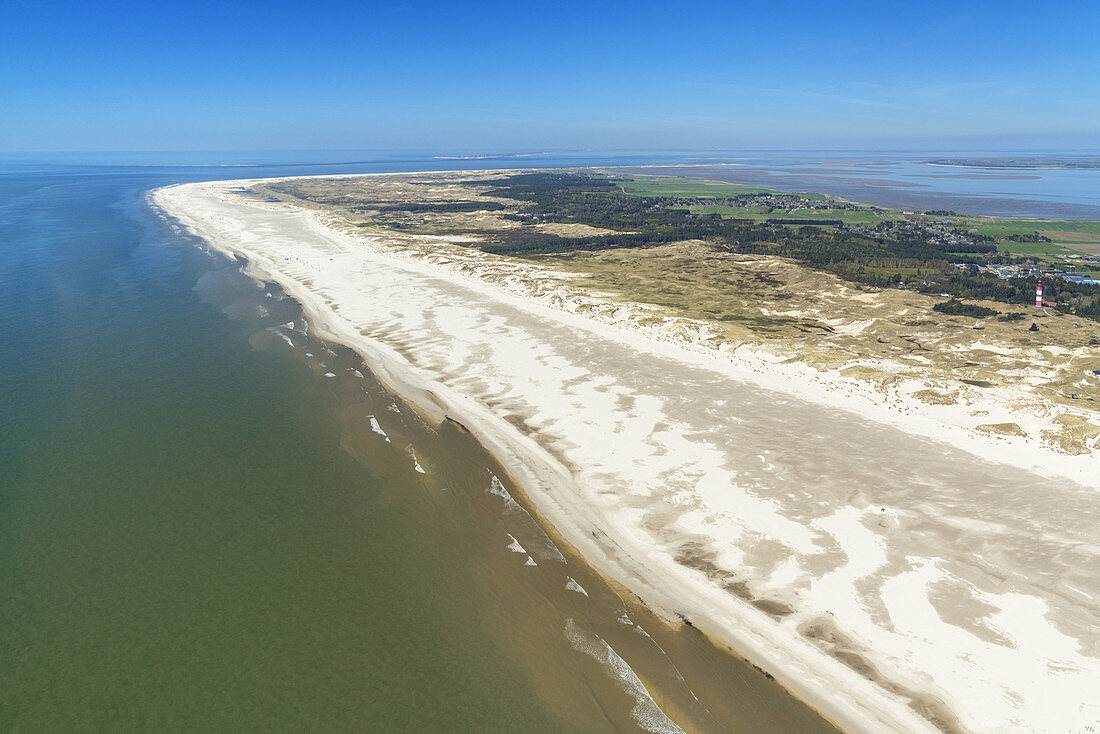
[{"left": 0, "top": 147, "right": 1100, "bottom": 732}]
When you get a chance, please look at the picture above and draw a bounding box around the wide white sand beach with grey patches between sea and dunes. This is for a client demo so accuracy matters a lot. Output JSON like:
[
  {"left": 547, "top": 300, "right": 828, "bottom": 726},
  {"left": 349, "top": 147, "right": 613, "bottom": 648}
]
[{"left": 153, "top": 182, "right": 1100, "bottom": 732}]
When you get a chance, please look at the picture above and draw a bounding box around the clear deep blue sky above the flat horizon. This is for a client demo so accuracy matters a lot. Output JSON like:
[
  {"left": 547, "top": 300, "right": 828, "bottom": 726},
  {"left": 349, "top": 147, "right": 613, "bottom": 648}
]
[{"left": 0, "top": 0, "right": 1100, "bottom": 152}]
